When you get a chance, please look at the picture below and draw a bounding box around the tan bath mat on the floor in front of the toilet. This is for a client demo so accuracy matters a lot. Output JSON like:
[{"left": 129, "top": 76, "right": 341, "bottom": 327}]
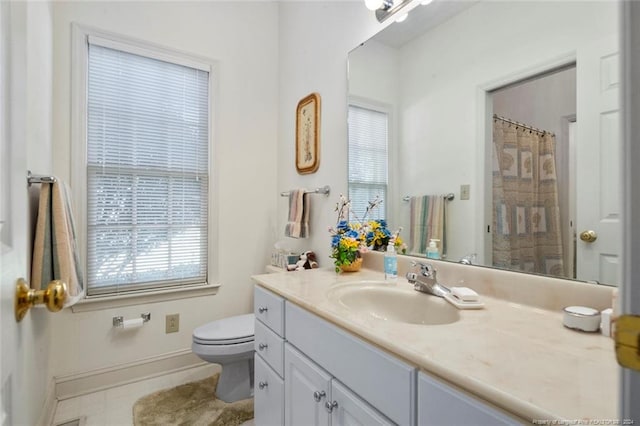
[{"left": 133, "top": 374, "right": 253, "bottom": 426}]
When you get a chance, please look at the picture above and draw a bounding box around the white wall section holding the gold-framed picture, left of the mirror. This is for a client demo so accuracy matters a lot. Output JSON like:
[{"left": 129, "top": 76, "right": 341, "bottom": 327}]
[{"left": 277, "top": 1, "right": 382, "bottom": 267}]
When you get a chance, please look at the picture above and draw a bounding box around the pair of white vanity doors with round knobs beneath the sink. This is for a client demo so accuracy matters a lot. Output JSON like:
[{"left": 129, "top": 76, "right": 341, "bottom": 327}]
[{"left": 284, "top": 343, "right": 393, "bottom": 426}]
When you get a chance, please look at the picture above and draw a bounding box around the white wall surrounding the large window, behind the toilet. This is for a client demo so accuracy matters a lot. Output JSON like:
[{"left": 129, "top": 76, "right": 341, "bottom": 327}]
[{"left": 52, "top": 1, "right": 280, "bottom": 376}]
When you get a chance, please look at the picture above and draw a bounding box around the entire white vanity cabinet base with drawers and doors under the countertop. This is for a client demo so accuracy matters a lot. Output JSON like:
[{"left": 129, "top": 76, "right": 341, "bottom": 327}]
[{"left": 254, "top": 287, "right": 523, "bottom": 426}]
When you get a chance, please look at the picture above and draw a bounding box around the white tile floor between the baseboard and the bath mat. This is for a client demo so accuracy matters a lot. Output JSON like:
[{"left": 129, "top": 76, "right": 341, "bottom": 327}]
[{"left": 53, "top": 365, "right": 253, "bottom": 426}]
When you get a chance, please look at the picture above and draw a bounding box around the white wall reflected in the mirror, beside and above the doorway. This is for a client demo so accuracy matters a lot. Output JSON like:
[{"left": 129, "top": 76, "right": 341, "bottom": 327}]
[{"left": 399, "top": 1, "right": 617, "bottom": 259}]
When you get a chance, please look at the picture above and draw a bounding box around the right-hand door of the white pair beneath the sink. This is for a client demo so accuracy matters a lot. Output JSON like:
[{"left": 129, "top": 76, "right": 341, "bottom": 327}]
[{"left": 329, "top": 379, "right": 394, "bottom": 426}]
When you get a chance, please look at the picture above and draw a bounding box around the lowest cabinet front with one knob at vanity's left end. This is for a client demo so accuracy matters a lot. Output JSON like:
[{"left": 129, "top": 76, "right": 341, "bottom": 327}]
[{"left": 253, "top": 356, "right": 284, "bottom": 426}]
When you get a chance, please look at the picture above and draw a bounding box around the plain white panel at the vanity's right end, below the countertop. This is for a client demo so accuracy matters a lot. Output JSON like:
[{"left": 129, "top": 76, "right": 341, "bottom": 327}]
[{"left": 418, "top": 372, "right": 521, "bottom": 426}]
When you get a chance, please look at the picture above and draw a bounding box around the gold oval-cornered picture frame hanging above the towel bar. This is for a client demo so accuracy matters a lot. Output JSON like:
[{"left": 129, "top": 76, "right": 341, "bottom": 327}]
[{"left": 296, "top": 93, "right": 320, "bottom": 175}]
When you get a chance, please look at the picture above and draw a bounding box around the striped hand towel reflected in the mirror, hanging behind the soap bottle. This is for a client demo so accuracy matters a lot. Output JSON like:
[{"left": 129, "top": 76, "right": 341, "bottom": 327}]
[{"left": 409, "top": 195, "right": 447, "bottom": 258}]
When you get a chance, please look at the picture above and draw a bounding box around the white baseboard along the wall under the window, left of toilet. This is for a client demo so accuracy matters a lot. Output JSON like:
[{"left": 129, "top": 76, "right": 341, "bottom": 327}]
[{"left": 54, "top": 349, "right": 207, "bottom": 402}]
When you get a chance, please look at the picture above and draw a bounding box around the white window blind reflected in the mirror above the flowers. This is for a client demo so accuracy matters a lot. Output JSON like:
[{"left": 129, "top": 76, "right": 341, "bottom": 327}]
[{"left": 349, "top": 105, "right": 389, "bottom": 219}]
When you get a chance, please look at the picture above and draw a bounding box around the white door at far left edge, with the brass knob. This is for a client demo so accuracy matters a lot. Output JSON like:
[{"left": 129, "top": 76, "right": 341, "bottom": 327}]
[{"left": 0, "top": 2, "right": 30, "bottom": 425}]
